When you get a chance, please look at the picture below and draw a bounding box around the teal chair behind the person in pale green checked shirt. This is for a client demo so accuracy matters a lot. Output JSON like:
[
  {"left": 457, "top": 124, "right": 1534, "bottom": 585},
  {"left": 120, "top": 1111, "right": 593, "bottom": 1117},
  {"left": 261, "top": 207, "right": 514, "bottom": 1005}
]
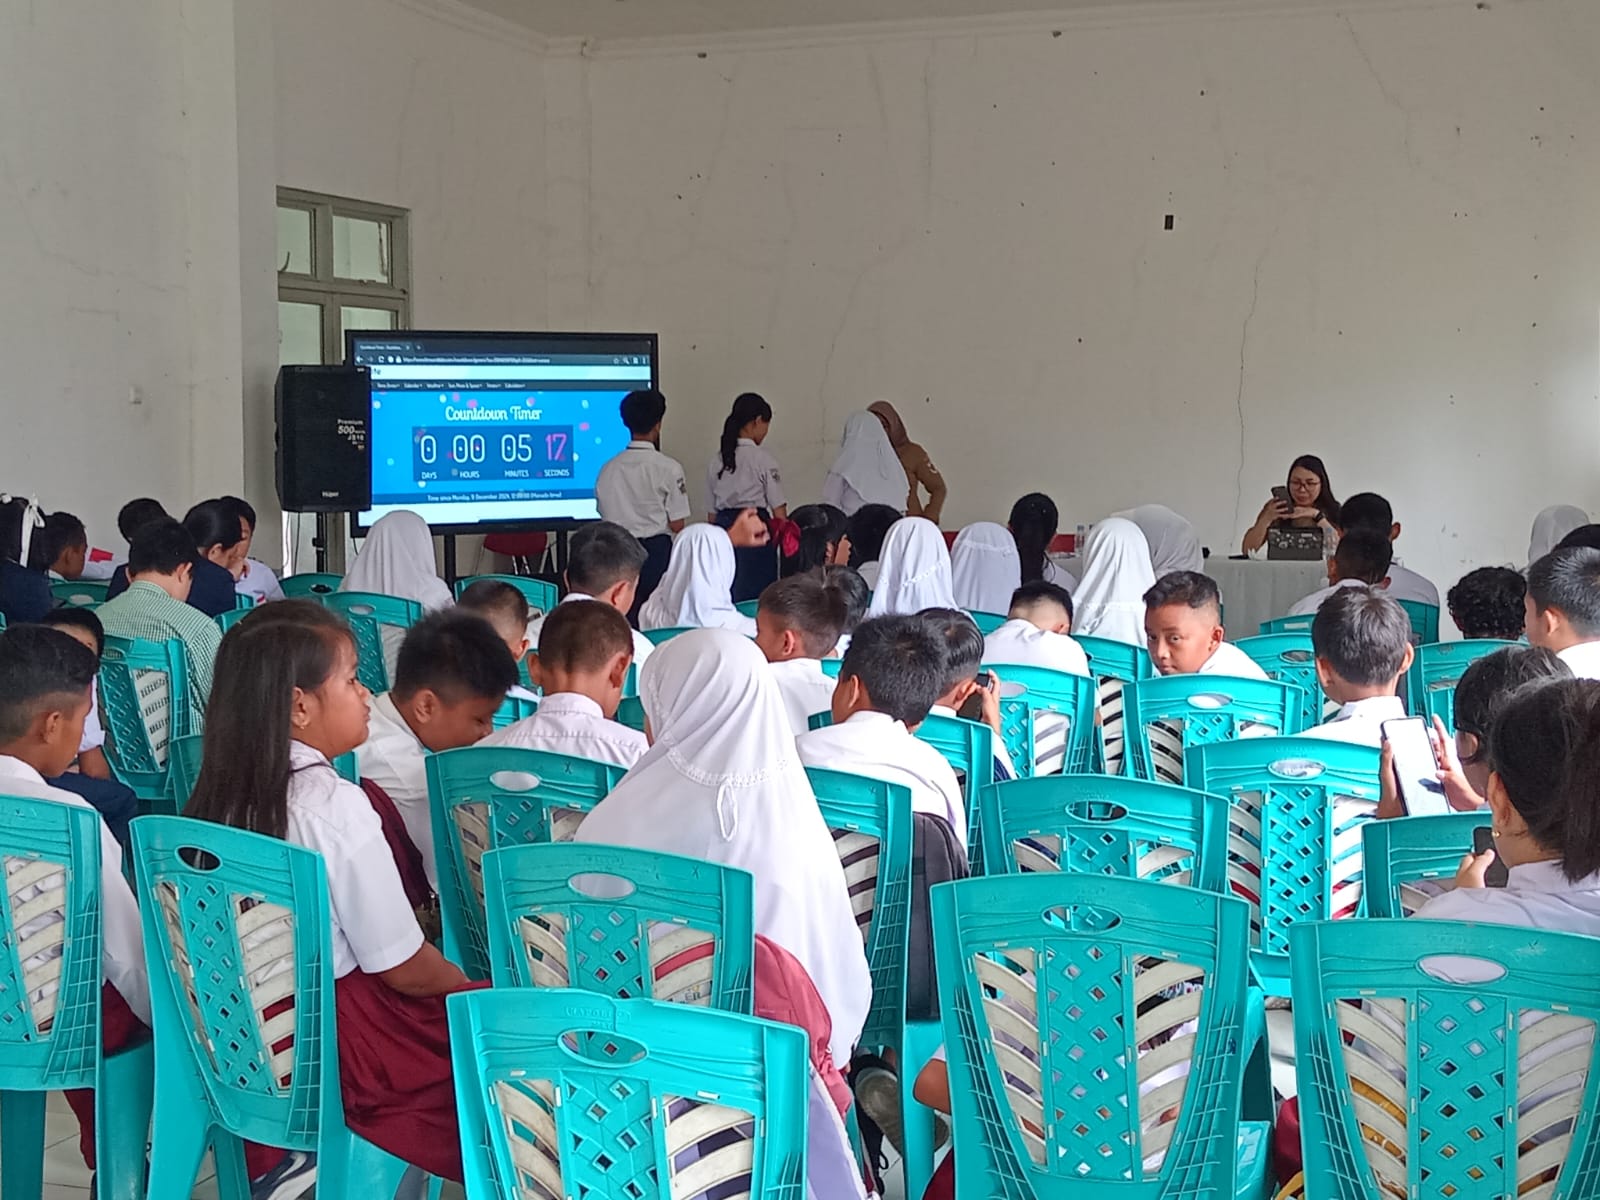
[{"left": 99, "top": 637, "right": 190, "bottom": 811}]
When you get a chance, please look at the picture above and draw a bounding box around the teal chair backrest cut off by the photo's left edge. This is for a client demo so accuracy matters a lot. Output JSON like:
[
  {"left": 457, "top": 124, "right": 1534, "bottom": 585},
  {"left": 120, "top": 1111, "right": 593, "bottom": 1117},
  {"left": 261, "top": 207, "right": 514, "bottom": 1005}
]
[{"left": 0, "top": 795, "right": 101, "bottom": 1094}]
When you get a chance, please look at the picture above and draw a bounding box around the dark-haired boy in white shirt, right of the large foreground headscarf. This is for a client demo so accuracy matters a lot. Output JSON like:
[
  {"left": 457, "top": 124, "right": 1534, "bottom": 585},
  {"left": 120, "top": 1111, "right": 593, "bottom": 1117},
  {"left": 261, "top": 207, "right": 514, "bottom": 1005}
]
[{"left": 795, "top": 616, "right": 966, "bottom": 846}]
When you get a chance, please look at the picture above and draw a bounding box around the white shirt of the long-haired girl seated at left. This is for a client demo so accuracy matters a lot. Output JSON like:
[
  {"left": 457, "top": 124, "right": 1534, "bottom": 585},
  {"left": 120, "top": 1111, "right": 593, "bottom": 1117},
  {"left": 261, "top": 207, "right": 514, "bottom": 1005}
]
[{"left": 283, "top": 742, "right": 430, "bottom": 979}]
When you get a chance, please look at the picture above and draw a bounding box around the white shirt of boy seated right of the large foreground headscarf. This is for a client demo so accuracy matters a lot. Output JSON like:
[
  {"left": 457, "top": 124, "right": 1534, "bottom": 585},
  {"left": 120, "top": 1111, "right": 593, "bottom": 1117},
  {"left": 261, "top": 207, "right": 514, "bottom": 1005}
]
[{"left": 795, "top": 712, "right": 966, "bottom": 850}]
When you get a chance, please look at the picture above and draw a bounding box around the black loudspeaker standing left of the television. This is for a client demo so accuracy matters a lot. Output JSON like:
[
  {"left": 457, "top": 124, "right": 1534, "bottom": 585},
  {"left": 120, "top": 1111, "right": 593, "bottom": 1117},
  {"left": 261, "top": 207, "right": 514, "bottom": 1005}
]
[{"left": 274, "top": 366, "right": 373, "bottom": 512}]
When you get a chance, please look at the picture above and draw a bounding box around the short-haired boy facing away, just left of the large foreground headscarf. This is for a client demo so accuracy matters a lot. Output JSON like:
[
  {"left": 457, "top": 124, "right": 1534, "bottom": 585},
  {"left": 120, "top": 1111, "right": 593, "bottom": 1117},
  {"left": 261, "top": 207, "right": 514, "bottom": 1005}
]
[{"left": 483, "top": 600, "right": 650, "bottom": 766}]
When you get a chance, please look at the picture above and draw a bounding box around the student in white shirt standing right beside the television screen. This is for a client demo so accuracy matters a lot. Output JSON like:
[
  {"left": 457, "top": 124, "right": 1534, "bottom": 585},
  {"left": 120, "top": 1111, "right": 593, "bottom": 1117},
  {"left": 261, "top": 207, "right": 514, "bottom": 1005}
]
[{"left": 595, "top": 390, "right": 690, "bottom": 613}]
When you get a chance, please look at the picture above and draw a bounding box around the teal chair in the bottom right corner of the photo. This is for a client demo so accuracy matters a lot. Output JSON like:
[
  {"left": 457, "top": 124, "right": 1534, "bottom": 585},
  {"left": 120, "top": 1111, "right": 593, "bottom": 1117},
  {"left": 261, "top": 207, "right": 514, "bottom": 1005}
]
[{"left": 1290, "top": 920, "right": 1600, "bottom": 1200}]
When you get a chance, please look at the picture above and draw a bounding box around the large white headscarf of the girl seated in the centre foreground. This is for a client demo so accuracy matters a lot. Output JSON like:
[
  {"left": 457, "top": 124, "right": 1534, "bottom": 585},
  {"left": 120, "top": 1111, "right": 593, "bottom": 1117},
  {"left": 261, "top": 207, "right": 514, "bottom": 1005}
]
[{"left": 574, "top": 629, "right": 872, "bottom": 1066}]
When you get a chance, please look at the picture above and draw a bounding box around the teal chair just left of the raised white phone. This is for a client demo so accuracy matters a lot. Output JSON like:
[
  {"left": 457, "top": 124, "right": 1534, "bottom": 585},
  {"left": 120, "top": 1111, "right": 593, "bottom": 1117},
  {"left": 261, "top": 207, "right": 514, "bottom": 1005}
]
[{"left": 1186, "top": 738, "right": 1382, "bottom": 995}]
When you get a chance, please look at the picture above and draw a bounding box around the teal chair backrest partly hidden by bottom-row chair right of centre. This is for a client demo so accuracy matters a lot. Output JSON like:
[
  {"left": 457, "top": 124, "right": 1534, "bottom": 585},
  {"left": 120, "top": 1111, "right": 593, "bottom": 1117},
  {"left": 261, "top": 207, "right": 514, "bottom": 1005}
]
[{"left": 982, "top": 774, "right": 1227, "bottom": 891}]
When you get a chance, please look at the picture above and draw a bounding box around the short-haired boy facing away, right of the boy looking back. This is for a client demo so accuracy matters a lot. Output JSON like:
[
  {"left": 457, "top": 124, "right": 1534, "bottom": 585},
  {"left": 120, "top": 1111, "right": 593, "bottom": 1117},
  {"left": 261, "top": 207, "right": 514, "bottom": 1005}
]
[{"left": 1306, "top": 587, "right": 1416, "bottom": 749}]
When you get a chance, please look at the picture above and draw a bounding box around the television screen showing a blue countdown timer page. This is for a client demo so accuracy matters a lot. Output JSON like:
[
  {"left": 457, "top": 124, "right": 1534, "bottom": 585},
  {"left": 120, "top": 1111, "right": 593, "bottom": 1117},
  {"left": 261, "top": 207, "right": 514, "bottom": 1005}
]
[{"left": 346, "top": 330, "right": 656, "bottom": 533}]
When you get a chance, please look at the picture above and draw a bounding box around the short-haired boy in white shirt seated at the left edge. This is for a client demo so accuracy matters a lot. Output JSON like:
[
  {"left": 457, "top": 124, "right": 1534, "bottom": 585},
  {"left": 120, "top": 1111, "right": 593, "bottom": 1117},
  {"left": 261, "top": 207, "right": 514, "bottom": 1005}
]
[{"left": 0, "top": 626, "right": 150, "bottom": 1170}]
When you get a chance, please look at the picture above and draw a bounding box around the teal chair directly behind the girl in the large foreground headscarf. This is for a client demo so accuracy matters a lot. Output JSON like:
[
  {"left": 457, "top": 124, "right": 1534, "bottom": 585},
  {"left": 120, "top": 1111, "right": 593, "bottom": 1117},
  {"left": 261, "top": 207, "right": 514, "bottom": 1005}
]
[{"left": 483, "top": 842, "right": 755, "bottom": 1013}]
